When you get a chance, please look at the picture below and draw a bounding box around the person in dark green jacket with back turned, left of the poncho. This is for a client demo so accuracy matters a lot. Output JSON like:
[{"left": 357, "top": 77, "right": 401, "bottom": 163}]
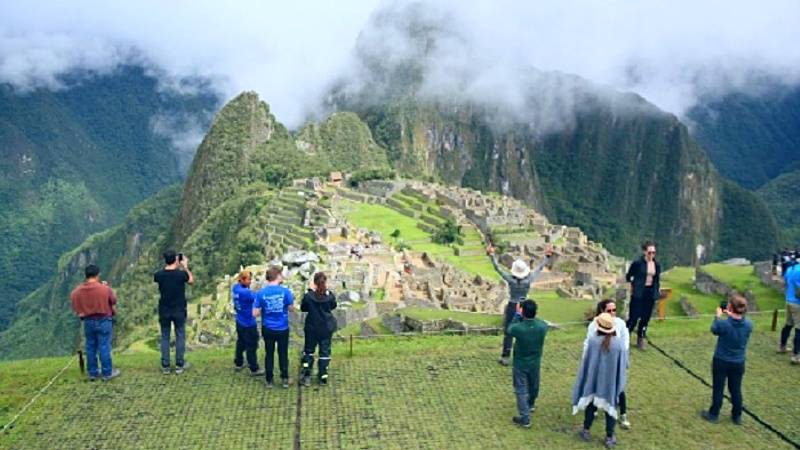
[{"left": 506, "top": 300, "right": 547, "bottom": 428}]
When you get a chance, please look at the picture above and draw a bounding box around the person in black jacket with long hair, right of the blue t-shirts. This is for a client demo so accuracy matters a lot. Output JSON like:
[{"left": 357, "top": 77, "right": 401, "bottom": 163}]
[{"left": 300, "top": 272, "right": 336, "bottom": 387}]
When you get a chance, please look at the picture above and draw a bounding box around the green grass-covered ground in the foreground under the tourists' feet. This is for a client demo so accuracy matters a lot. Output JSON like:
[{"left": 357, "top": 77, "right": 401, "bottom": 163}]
[{"left": 0, "top": 319, "right": 800, "bottom": 449}]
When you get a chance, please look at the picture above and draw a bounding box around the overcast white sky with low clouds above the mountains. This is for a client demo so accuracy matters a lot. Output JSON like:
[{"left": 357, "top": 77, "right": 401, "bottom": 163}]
[{"left": 0, "top": 0, "right": 800, "bottom": 127}]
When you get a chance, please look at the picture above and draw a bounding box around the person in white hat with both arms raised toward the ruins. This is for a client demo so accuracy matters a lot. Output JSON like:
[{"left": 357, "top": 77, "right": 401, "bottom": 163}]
[{"left": 486, "top": 245, "right": 553, "bottom": 366}]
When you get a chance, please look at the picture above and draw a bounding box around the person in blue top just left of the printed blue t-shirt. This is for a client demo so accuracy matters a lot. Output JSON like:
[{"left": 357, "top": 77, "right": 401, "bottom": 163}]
[{"left": 231, "top": 270, "right": 264, "bottom": 376}]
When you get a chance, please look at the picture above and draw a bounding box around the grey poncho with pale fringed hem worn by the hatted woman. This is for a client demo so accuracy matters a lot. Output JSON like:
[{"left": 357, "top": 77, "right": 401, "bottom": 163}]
[{"left": 572, "top": 336, "right": 628, "bottom": 418}]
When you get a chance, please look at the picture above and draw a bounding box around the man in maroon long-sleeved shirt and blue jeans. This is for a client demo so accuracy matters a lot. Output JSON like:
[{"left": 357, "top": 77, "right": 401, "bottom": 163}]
[{"left": 70, "top": 264, "right": 120, "bottom": 381}]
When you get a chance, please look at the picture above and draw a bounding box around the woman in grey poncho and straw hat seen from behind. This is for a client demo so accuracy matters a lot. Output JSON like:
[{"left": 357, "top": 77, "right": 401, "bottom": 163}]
[{"left": 572, "top": 313, "right": 628, "bottom": 448}]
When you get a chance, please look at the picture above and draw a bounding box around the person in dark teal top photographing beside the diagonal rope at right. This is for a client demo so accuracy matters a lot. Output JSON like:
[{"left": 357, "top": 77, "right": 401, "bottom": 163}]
[{"left": 700, "top": 294, "right": 753, "bottom": 425}]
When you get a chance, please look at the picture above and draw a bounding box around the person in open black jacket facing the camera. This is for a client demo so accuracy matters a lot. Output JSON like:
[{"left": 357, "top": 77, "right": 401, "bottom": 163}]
[{"left": 625, "top": 241, "right": 661, "bottom": 350}]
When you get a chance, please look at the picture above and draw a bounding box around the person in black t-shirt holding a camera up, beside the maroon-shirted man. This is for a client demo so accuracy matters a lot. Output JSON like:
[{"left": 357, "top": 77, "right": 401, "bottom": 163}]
[{"left": 153, "top": 250, "right": 194, "bottom": 375}]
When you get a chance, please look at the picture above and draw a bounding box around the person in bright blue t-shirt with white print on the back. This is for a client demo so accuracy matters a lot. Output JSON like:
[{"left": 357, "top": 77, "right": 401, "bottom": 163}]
[{"left": 253, "top": 267, "right": 294, "bottom": 388}]
